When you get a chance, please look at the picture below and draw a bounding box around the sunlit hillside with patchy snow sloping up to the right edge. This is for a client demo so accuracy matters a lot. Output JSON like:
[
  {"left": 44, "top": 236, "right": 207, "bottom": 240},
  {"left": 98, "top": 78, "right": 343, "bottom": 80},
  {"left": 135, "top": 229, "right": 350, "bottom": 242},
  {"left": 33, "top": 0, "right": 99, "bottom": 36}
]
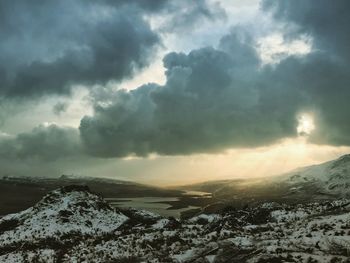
[{"left": 179, "top": 154, "right": 350, "bottom": 200}]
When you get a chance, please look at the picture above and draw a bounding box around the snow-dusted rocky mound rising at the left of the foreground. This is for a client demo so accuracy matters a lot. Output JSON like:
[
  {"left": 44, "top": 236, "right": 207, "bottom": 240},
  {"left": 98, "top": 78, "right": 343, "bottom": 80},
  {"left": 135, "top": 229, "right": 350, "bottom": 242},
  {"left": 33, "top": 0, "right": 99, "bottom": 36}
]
[{"left": 0, "top": 186, "right": 128, "bottom": 249}]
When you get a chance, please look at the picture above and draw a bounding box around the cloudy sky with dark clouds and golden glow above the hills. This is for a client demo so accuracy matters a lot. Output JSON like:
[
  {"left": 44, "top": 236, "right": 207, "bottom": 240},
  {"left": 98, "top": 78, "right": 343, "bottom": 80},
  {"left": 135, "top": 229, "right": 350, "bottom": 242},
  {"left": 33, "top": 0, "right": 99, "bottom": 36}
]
[{"left": 0, "top": 0, "right": 350, "bottom": 185}]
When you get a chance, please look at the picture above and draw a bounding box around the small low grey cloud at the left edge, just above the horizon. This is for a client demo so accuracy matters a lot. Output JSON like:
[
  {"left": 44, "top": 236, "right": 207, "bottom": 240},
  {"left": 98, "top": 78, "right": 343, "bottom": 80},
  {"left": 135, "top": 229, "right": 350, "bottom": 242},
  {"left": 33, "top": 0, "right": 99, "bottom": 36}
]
[{"left": 0, "top": 124, "right": 81, "bottom": 161}]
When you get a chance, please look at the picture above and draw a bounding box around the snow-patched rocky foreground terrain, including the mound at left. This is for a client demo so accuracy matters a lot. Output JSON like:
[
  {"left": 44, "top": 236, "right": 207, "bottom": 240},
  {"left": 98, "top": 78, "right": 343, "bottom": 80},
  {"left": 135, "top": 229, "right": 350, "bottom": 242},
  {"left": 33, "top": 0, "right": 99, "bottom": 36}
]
[{"left": 0, "top": 186, "right": 350, "bottom": 263}]
